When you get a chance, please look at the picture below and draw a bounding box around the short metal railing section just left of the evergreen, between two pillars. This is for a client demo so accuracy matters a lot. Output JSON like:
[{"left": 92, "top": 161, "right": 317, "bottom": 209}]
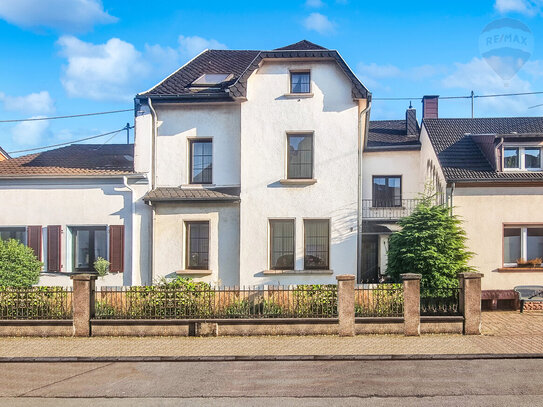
[{"left": 354, "top": 284, "right": 403, "bottom": 317}]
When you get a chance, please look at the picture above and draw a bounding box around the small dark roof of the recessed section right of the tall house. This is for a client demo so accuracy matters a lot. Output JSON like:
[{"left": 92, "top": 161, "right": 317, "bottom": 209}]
[{"left": 365, "top": 120, "right": 420, "bottom": 151}]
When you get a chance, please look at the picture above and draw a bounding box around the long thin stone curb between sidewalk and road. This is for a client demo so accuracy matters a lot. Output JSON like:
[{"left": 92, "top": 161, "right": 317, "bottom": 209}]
[{"left": 0, "top": 353, "right": 543, "bottom": 363}]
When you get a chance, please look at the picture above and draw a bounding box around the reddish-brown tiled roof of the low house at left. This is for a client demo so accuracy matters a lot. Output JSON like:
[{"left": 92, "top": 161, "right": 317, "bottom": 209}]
[{"left": 0, "top": 144, "right": 134, "bottom": 178}]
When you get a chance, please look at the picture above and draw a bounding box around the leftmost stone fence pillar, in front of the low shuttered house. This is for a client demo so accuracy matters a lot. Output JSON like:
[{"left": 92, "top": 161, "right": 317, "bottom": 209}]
[{"left": 70, "top": 274, "right": 97, "bottom": 336}]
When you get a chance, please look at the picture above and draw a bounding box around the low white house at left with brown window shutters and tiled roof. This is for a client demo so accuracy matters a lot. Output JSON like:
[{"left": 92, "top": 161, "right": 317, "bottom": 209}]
[{"left": 0, "top": 144, "right": 150, "bottom": 285}]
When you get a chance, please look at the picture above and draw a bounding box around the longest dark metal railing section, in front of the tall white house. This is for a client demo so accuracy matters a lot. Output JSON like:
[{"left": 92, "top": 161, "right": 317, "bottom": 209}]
[{"left": 95, "top": 285, "right": 337, "bottom": 319}]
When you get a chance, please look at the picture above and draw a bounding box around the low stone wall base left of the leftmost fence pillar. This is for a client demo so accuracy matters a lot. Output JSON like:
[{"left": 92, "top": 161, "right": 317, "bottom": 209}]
[{"left": 0, "top": 320, "right": 74, "bottom": 337}]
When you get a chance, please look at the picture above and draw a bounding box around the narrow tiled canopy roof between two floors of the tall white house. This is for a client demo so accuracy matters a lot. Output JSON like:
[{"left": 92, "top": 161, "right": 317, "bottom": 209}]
[{"left": 143, "top": 187, "right": 240, "bottom": 202}]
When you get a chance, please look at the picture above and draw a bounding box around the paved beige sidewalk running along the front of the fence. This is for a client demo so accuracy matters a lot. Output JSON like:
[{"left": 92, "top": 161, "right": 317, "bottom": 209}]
[{"left": 0, "top": 311, "right": 543, "bottom": 361}]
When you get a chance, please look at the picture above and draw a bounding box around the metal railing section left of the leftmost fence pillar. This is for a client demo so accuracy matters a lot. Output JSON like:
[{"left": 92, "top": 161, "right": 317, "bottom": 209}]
[{"left": 0, "top": 287, "right": 73, "bottom": 320}]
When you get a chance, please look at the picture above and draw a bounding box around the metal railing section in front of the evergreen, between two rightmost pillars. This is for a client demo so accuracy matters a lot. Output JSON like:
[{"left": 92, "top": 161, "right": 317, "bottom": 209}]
[{"left": 420, "top": 287, "right": 461, "bottom": 316}]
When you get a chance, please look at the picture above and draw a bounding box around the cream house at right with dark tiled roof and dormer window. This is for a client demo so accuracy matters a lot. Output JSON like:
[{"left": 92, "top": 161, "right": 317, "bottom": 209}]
[{"left": 421, "top": 110, "right": 543, "bottom": 289}]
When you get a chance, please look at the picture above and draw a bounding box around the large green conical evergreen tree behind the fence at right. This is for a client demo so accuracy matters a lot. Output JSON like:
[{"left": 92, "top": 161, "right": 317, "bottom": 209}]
[{"left": 387, "top": 198, "right": 474, "bottom": 295}]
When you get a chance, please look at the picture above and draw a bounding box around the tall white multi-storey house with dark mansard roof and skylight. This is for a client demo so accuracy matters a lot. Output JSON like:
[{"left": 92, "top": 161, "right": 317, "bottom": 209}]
[{"left": 135, "top": 41, "right": 371, "bottom": 285}]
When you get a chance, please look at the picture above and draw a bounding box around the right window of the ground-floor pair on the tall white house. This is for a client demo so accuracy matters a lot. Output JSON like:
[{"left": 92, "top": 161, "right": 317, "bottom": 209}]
[{"left": 304, "top": 219, "right": 330, "bottom": 270}]
